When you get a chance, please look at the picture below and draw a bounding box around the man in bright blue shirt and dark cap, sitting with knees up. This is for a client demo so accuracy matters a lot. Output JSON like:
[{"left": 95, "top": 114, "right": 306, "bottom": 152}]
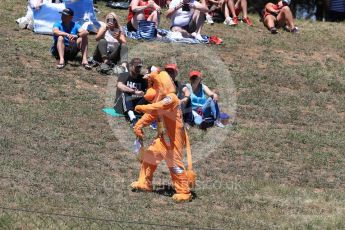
[{"left": 52, "top": 8, "right": 91, "bottom": 70}]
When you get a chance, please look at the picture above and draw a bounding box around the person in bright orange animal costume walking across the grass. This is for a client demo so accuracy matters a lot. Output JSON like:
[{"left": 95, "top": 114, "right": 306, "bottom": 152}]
[{"left": 131, "top": 71, "right": 195, "bottom": 202}]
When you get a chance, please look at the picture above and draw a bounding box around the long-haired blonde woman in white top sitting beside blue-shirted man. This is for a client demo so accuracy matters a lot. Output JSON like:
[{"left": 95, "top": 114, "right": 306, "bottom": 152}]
[{"left": 93, "top": 12, "right": 128, "bottom": 72}]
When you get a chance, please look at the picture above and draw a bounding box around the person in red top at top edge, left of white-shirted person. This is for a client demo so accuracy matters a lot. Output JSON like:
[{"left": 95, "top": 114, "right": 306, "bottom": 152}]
[{"left": 127, "top": 0, "right": 161, "bottom": 31}]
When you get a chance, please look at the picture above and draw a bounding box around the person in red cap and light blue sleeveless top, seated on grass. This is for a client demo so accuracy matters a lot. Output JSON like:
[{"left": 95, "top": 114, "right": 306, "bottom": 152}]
[{"left": 186, "top": 70, "right": 224, "bottom": 128}]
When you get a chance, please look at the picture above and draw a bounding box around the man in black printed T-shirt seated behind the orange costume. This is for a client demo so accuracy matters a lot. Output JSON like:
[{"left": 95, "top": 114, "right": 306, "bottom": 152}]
[{"left": 114, "top": 58, "right": 147, "bottom": 125}]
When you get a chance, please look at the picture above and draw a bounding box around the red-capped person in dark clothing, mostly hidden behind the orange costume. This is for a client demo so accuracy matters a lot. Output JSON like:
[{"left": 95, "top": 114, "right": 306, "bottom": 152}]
[{"left": 164, "top": 63, "right": 193, "bottom": 128}]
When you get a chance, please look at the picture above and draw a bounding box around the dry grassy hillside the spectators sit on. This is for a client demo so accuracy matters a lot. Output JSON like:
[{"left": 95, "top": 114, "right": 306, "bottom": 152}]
[{"left": 0, "top": 0, "right": 345, "bottom": 229}]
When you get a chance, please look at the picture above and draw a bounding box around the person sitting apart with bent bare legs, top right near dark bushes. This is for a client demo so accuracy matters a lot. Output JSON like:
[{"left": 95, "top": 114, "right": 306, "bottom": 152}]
[{"left": 263, "top": 0, "right": 298, "bottom": 34}]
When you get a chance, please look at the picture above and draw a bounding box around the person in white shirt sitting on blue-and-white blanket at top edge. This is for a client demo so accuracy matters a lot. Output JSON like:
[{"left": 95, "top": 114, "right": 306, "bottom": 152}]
[{"left": 167, "top": 0, "right": 208, "bottom": 40}]
